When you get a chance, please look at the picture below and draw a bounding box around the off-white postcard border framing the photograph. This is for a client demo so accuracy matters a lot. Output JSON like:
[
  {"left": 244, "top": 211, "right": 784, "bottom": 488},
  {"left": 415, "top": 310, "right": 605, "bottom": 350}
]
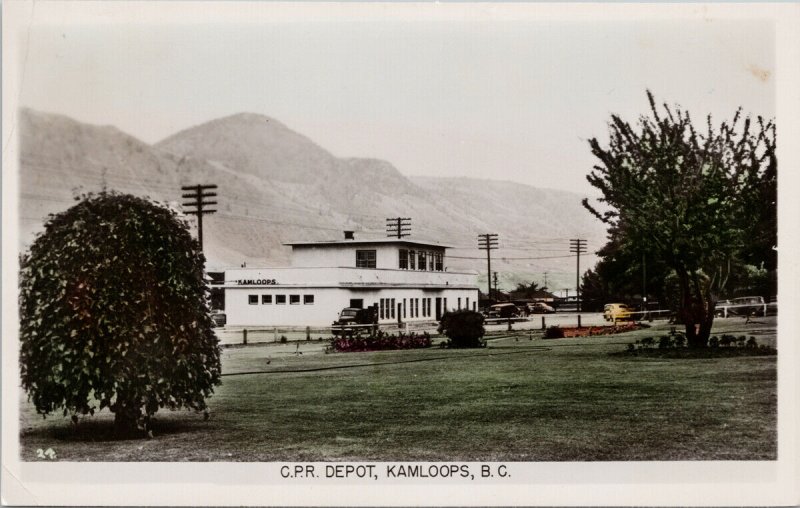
[{"left": 2, "top": 2, "right": 800, "bottom": 506}]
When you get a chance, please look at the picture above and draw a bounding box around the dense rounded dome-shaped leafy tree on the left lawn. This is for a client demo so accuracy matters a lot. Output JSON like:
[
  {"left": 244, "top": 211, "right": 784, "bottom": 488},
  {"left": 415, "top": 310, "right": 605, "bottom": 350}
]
[{"left": 20, "top": 193, "right": 220, "bottom": 433}]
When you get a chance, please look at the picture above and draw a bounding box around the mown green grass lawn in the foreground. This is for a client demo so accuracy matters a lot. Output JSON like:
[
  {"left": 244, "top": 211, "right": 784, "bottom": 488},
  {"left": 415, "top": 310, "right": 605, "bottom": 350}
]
[{"left": 20, "top": 318, "right": 777, "bottom": 461}]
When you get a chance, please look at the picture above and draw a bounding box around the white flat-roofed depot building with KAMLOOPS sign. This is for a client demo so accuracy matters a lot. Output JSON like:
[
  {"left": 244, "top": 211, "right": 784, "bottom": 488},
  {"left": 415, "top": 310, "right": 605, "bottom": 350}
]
[{"left": 223, "top": 235, "right": 478, "bottom": 326}]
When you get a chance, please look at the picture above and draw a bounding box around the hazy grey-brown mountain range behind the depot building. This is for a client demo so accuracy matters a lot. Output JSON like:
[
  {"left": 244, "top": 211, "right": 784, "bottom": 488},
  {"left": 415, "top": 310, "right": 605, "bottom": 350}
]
[{"left": 19, "top": 109, "right": 604, "bottom": 288}]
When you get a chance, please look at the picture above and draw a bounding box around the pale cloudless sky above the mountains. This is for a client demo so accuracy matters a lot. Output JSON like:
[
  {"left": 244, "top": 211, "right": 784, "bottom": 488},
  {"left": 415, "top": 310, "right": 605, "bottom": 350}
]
[{"left": 19, "top": 10, "right": 775, "bottom": 195}]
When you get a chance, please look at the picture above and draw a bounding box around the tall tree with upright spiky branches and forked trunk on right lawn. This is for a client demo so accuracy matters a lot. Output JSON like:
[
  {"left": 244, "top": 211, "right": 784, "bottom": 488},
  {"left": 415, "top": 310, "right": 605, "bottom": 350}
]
[{"left": 584, "top": 91, "right": 777, "bottom": 347}]
